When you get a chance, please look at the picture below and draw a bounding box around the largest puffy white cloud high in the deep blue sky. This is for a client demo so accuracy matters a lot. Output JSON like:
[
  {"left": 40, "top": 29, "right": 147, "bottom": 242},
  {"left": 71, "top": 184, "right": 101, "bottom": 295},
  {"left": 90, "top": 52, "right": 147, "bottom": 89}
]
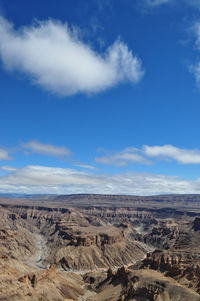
[{"left": 0, "top": 17, "right": 144, "bottom": 96}]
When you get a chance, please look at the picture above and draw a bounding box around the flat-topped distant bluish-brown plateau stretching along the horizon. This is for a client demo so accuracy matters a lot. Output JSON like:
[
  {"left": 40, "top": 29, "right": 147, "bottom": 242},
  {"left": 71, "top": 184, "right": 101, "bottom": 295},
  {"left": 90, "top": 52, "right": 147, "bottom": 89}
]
[{"left": 0, "top": 194, "right": 200, "bottom": 210}]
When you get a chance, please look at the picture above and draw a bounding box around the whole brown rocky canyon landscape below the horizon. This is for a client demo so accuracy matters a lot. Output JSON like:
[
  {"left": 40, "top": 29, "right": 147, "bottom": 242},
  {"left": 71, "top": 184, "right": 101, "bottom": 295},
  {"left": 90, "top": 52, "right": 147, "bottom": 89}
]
[{"left": 0, "top": 195, "right": 200, "bottom": 301}]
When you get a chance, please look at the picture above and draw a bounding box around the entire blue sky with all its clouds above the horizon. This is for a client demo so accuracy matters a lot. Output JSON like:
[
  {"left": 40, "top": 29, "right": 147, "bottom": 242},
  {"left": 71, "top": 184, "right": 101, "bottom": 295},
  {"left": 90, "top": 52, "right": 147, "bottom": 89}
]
[{"left": 0, "top": 0, "right": 200, "bottom": 195}]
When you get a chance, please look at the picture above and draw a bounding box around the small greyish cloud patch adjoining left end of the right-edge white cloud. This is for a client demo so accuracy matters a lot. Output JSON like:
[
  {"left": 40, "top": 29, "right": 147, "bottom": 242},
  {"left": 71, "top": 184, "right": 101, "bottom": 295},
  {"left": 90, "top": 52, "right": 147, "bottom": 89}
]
[{"left": 95, "top": 148, "right": 151, "bottom": 166}]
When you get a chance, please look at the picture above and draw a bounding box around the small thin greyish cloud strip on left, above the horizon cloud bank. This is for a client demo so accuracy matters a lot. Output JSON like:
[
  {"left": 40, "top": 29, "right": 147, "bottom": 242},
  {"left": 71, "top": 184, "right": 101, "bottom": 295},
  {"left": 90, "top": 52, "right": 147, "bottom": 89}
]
[{"left": 22, "top": 140, "right": 71, "bottom": 157}]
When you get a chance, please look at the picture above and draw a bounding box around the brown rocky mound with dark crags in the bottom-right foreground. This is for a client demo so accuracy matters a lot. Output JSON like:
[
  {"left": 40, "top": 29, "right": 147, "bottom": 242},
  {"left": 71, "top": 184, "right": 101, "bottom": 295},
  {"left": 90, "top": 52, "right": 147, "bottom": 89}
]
[{"left": 91, "top": 267, "right": 200, "bottom": 301}]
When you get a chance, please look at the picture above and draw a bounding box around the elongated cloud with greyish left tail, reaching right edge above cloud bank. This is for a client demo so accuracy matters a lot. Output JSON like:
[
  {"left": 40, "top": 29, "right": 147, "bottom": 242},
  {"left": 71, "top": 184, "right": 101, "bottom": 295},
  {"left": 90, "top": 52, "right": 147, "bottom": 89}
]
[{"left": 95, "top": 145, "right": 200, "bottom": 166}]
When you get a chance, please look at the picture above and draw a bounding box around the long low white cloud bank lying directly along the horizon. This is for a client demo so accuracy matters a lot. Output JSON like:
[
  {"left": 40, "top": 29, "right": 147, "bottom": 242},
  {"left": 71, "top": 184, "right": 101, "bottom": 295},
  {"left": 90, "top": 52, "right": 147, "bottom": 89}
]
[{"left": 0, "top": 166, "right": 200, "bottom": 195}]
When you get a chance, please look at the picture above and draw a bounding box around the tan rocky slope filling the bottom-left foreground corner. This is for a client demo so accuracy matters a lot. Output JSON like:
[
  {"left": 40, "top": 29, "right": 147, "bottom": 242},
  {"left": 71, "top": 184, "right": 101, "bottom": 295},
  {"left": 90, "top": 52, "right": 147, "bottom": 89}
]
[{"left": 0, "top": 261, "right": 84, "bottom": 301}]
